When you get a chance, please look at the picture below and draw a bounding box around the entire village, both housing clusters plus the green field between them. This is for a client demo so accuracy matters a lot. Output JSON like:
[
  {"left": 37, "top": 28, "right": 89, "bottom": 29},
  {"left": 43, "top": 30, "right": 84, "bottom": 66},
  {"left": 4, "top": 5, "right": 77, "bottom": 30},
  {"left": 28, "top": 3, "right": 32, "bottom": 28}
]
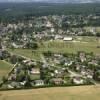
[{"left": 0, "top": 15, "right": 100, "bottom": 89}]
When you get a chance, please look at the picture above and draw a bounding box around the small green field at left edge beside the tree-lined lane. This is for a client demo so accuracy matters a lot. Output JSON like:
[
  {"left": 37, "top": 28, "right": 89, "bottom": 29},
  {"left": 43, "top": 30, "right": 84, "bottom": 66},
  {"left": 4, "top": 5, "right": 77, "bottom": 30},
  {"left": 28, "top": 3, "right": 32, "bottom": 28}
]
[{"left": 0, "top": 60, "right": 12, "bottom": 80}]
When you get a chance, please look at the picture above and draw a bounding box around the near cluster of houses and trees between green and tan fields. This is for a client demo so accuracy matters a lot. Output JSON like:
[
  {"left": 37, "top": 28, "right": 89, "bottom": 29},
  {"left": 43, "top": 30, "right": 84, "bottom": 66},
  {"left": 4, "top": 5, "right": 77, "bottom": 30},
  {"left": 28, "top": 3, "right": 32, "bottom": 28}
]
[{"left": 0, "top": 42, "right": 100, "bottom": 89}]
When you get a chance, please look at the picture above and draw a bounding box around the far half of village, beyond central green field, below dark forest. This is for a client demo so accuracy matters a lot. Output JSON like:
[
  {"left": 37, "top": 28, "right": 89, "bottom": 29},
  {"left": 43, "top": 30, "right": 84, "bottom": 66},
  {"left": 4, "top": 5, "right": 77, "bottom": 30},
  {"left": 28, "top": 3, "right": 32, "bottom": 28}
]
[{"left": 0, "top": 15, "right": 100, "bottom": 48}]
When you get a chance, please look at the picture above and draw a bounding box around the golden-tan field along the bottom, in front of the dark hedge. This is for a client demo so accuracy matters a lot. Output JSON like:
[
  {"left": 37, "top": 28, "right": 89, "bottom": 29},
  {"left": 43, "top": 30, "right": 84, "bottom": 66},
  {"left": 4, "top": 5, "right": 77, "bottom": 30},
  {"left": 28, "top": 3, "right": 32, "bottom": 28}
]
[{"left": 0, "top": 86, "right": 100, "bottom": 100}]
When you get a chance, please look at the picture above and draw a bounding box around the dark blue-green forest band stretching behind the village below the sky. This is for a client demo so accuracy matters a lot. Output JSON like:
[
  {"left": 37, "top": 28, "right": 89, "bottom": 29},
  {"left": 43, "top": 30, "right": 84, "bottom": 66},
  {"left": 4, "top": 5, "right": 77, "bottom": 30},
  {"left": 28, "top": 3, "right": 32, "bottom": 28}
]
[{"left": 0, "top": 3, "right": 100, "bottom": 22}]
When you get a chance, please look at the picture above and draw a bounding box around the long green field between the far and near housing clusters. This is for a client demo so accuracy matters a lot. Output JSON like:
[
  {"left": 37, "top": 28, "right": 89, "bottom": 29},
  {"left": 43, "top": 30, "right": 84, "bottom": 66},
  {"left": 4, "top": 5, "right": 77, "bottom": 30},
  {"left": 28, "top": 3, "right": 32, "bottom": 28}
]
[{"left": 8, "top": 37, "right": 100, "bottom": 60}]
